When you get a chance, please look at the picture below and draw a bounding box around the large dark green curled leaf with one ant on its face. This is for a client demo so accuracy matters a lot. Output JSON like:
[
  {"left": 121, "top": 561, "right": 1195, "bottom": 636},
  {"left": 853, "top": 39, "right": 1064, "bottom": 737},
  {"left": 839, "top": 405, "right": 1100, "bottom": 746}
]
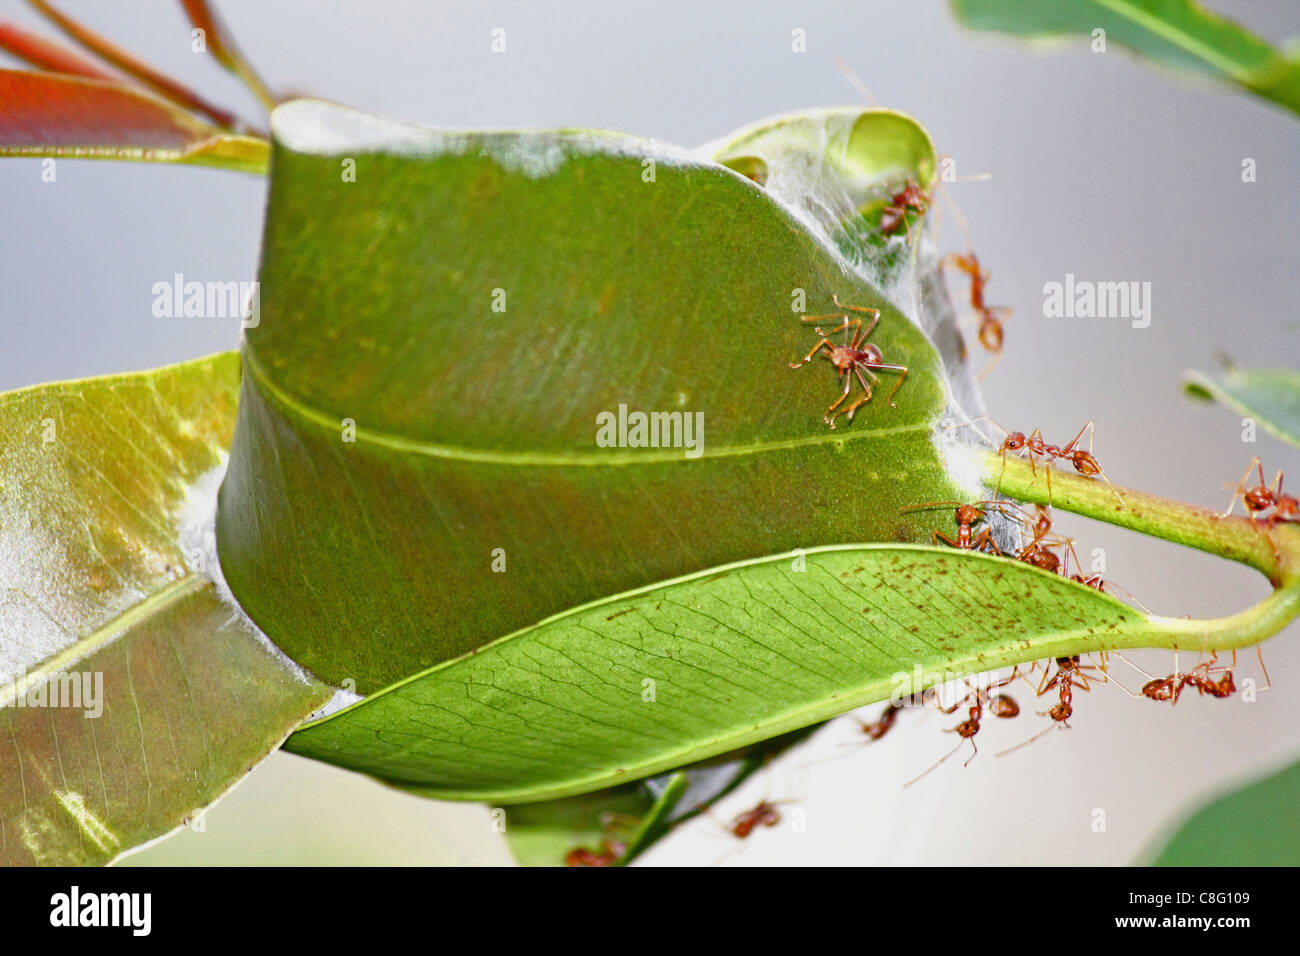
[{"left": 218, "top": 101, "right": 958, "bottom": 693}]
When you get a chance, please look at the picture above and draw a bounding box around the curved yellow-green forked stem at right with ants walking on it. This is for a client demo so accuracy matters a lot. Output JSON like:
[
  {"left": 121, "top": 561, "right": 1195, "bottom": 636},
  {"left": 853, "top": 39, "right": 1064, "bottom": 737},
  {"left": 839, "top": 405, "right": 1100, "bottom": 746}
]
[{"left": 983, "top": 451, "right": 1300, "bottom": 650}]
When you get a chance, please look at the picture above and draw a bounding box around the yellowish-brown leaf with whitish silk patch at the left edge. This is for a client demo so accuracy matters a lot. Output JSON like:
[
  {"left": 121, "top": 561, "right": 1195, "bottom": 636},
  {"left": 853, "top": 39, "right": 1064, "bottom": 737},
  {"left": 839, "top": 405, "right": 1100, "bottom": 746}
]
[{"left": 0, "top": 354, "right": 329, "bottom": 865}]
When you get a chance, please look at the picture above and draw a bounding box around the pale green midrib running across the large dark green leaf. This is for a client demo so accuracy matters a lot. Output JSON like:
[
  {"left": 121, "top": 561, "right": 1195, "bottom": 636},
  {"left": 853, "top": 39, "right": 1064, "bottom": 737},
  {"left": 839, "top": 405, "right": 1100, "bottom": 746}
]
[{"left": 243, "top": 347, "right": 933, "bottom": 467}]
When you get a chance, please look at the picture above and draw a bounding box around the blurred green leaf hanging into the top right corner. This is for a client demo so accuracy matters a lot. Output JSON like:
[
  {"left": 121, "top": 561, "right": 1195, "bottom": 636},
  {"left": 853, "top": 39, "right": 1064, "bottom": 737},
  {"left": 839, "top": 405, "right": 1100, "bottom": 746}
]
[{"left": 952, "top": 0, "right": 1300, "bottom": 113}]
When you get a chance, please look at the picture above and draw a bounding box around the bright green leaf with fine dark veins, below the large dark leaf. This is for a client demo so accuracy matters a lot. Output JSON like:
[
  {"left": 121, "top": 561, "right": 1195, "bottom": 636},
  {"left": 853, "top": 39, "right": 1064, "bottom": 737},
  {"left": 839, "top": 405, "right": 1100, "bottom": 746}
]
[{"left": 286, "top": 545, "right": 1159, "bottom": 804}]
